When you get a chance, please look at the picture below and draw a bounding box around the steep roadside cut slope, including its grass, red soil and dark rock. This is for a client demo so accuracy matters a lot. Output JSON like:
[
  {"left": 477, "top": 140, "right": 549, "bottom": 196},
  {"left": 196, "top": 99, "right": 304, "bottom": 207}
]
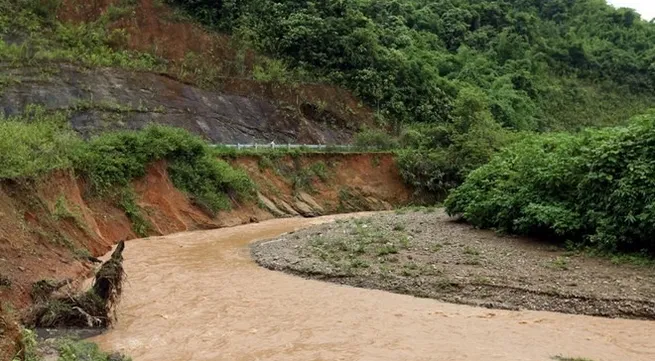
[{"left": 0, "top": 0, "right": 373, "bottom": 144}]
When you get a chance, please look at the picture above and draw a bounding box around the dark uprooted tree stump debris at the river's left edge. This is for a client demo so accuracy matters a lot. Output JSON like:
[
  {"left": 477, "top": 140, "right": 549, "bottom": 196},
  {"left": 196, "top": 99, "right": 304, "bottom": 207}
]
[{"left": 28, "top": 241, "right": 125, "bottom": 328}]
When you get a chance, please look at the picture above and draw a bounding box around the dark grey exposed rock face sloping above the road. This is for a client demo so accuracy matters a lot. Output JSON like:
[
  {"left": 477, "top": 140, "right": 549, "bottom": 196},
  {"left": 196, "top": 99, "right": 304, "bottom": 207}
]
[{"left": 0, "top": 64, "right": 355, "bottom": 144}]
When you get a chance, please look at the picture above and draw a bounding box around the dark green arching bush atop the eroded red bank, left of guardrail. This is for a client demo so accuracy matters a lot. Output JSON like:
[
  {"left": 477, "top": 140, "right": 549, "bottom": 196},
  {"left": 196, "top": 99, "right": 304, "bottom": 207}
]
[{"left": 76, "top": 126, "right": 254, "bottom": 213}]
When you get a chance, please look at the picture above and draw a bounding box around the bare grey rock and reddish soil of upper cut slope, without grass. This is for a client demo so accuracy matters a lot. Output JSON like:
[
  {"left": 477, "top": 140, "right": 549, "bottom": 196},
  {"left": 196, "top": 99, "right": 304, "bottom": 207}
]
[{"left": 0, "top": 0, "right": 374, "bottom": 144}]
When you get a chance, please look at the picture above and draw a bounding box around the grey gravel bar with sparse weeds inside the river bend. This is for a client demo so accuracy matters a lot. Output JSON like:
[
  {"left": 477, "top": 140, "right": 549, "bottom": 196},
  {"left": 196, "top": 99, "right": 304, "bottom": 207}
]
[{"left": 252, "top": 209, "right": 655, "bottom": 319}]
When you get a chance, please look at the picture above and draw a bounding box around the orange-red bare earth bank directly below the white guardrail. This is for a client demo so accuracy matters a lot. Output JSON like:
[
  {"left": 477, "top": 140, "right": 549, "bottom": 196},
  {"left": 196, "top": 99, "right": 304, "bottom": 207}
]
[{"left": 232, "top": 153, "right": 412, "bottom": 213}]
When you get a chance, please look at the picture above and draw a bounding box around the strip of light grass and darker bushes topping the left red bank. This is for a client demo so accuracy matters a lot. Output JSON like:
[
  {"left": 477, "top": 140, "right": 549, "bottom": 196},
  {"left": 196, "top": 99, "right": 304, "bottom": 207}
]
[{"left": 0, "top": 107, "right": 254, "bottom": 222}]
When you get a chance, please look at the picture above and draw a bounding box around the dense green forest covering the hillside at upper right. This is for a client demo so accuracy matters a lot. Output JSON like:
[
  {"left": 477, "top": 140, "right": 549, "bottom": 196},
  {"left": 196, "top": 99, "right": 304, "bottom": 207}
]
[{"left": 170, "top": 0, "right": 655, "bottom": 130}]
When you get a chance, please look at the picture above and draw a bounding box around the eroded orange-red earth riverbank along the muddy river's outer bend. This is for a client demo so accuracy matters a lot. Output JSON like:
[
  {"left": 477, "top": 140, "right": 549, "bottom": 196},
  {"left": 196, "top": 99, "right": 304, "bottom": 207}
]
[{"left": 0, "top": 154, "right": 410, "bottom": 316}]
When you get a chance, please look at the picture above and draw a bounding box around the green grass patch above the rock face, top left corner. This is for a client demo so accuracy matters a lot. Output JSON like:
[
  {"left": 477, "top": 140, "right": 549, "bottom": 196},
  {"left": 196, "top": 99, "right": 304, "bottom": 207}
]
[{"left": 0, "top": 0, "right": 165, "bottom": 71}]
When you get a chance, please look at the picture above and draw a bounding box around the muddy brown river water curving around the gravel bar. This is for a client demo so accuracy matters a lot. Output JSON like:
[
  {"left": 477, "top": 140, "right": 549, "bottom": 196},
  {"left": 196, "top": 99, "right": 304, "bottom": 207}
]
[{"left": 93, "top": 215, "right": 655, "bottom": 361}]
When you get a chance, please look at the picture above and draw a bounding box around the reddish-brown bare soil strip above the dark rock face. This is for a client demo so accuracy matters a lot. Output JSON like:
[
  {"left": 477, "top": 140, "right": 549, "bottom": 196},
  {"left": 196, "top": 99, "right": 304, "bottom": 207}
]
[{"left": 58, "top": 0, "right": 374, "bottom": 134}]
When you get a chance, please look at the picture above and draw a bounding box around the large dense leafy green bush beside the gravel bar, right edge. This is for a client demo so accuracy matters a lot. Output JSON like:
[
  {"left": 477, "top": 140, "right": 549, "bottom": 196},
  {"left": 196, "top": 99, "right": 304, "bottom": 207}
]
[{"left": 446, "top": 113, "right": 655, "bottom": 253}]
